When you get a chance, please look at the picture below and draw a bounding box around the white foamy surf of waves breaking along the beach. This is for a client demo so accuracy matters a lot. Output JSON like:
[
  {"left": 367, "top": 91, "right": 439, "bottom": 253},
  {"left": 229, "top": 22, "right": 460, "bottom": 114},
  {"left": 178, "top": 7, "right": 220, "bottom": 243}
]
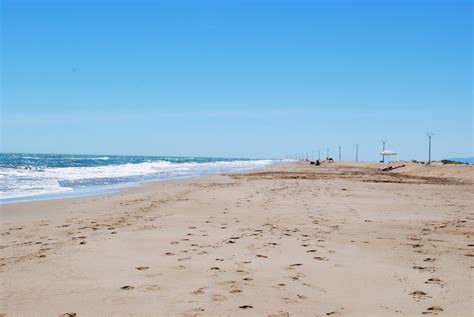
[{"left": 0, "top": 157, "right": 273, "bottom": 199}]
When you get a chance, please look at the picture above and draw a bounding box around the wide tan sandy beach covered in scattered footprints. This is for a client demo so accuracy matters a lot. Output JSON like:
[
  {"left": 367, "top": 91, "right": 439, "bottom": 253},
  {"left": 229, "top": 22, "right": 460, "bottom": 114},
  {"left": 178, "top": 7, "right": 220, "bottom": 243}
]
[{"left": 0, "top": 163, "right": 474, "bottom": 316}]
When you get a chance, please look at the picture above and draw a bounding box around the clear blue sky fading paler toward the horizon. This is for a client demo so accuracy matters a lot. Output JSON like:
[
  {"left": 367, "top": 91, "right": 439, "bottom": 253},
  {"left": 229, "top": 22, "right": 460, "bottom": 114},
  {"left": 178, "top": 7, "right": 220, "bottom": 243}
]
[{"left": 0, "top": 0, "right": 474, "bottom": 161}]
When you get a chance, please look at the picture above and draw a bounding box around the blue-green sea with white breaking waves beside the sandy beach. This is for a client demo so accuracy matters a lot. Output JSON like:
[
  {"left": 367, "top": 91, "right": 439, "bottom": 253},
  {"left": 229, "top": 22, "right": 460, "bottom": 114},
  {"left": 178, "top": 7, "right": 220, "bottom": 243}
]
[{"left": 0, "top": 153, "right": 275, "bottom": 202}]
